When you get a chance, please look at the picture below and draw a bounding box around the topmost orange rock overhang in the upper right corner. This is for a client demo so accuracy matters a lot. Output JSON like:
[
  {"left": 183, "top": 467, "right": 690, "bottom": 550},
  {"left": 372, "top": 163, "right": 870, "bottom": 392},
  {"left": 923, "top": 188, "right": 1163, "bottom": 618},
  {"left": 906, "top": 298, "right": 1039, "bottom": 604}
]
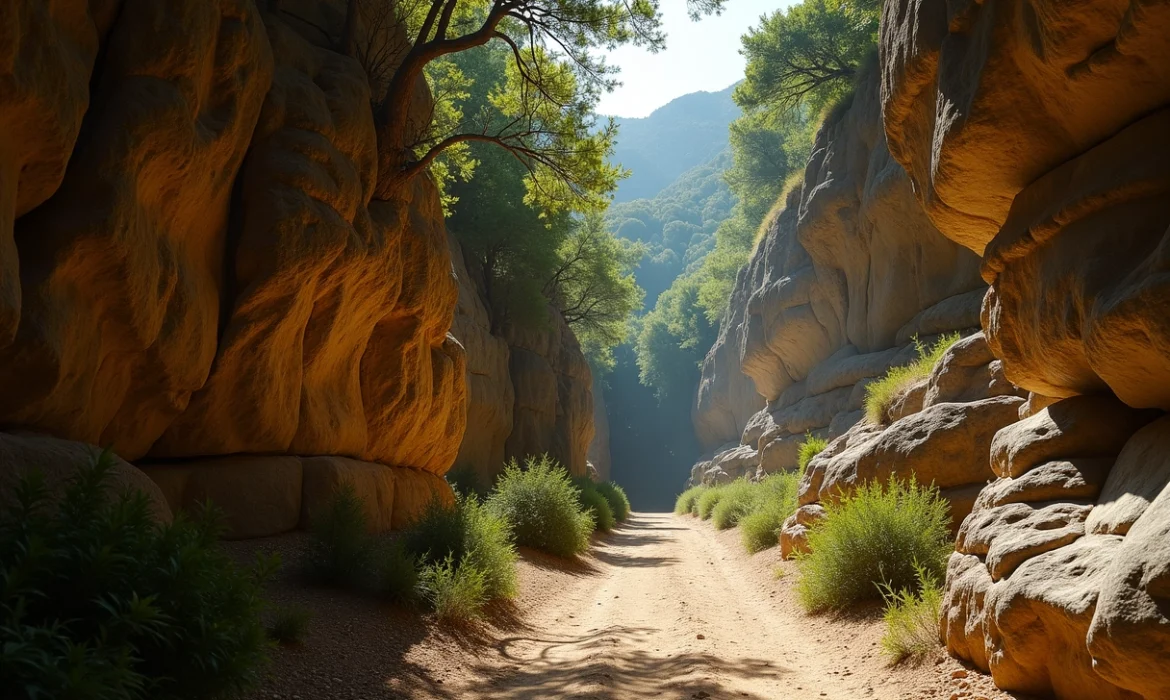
[{"left": 881, "top": 0, "right": 1170, "bottom": 257}]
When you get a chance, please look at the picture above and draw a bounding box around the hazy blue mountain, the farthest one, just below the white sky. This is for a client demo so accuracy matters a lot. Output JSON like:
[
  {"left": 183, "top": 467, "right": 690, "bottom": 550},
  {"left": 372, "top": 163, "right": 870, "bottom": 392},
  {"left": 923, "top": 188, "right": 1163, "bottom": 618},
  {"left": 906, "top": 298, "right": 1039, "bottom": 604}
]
[{"left": 612, "top": 85, "right": 739, "bottom": 201}]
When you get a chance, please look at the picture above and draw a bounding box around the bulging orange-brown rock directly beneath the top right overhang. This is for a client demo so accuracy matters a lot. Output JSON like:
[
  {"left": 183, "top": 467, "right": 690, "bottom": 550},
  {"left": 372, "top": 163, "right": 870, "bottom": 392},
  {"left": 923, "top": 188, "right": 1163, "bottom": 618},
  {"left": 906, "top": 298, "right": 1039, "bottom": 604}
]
[{"left": 984, "top": 107, "right": 1170, "bottom": 410}]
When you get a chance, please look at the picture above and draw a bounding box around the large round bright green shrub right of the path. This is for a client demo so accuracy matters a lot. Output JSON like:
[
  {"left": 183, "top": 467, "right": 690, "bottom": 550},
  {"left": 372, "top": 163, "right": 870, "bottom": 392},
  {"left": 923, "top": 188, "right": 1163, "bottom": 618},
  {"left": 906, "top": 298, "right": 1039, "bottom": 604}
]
[{"left": 797, "top": 478, "right": 952, "bottom": 611}]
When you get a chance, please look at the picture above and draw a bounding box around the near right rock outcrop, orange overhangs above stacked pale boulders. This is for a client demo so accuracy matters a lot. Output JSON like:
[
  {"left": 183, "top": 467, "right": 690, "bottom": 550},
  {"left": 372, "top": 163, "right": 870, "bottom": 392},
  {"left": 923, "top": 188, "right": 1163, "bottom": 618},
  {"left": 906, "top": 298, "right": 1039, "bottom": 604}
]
[{"left": 881, "top": 0, "right": 1170, "bottom": 699}]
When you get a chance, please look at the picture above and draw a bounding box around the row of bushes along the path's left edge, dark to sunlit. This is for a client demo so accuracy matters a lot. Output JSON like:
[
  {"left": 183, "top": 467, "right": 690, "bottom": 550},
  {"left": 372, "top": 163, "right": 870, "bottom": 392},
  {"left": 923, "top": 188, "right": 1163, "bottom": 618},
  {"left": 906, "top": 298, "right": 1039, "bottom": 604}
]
[{"left": 308, "top": 457, "right": 629, "bottom": 622}]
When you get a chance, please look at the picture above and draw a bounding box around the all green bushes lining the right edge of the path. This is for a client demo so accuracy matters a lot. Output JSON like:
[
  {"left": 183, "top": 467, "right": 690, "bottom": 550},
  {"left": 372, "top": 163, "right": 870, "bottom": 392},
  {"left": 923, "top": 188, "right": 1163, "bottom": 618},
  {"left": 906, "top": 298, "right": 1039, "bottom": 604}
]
[{"left": 675, "top": 438, "right": 954, "bottom": 663}]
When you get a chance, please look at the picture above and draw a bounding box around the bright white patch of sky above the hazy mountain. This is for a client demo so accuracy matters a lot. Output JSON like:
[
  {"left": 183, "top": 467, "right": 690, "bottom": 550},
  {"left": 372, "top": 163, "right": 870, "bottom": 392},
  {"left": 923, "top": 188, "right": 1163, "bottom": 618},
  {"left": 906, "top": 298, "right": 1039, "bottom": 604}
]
[{"left": 597, "top": 0, "right": 794, "bottom": 117}]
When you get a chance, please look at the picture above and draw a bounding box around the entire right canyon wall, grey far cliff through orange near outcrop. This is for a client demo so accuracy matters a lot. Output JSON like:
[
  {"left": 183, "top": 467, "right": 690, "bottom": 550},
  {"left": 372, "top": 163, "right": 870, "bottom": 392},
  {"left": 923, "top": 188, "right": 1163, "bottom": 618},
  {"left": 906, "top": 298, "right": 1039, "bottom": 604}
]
[{"left": 691, "top": 0, "right": 1170, "bottom": 700}]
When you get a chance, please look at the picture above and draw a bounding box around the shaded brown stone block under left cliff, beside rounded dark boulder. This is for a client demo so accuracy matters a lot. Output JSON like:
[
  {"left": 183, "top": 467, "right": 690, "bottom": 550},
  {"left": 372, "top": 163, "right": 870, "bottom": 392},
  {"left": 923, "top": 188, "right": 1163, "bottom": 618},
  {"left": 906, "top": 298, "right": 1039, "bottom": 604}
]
[{"left": 140, "top": 457, "right": 303, "bottom": 540}]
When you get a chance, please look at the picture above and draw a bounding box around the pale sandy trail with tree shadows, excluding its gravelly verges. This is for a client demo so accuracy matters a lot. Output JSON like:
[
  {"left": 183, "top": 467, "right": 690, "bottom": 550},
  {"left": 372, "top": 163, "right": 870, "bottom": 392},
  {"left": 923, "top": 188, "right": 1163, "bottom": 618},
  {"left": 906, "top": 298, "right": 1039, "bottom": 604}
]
[{"left": 444, "top": 514, "right": 908, "bottom": 700}]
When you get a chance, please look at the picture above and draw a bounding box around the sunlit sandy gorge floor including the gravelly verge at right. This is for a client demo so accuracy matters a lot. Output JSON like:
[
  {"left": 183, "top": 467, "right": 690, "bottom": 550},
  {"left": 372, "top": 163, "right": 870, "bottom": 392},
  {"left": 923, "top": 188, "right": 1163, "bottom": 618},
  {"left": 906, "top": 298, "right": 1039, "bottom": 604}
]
[{"left": 425, "top": 513, "right": 1005, "bottom": 700}]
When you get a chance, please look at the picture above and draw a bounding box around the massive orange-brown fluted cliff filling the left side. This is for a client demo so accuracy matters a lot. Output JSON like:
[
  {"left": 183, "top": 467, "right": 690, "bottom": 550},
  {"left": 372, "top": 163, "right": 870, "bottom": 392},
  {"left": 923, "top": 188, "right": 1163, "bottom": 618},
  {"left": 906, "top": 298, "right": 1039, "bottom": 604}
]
[{"left": 0, "top": 0, "right": 467, "bottom": 536}]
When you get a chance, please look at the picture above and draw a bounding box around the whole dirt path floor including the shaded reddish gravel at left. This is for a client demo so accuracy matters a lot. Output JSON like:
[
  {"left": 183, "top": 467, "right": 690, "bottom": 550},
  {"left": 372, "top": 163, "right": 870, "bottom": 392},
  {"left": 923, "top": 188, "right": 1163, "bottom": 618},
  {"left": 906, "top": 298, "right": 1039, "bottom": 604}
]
[{"left": 237, "top": 514, "right": 1012, "bottom": 700}]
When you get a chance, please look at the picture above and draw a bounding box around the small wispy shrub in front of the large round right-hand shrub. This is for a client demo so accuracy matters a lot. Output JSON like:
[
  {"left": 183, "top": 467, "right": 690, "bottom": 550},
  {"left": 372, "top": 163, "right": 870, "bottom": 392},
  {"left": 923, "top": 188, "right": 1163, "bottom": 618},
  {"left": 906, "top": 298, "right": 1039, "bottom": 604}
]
[{"left": 881, "top": 567, "right": 943, "bottom": 664}]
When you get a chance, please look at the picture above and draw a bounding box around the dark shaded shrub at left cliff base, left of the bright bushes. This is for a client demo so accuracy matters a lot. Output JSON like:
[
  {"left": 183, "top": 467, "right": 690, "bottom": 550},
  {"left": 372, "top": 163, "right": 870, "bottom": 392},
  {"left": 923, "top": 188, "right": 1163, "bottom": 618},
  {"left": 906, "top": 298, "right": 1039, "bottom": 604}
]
[{"left": 308, "top": 483, "right": 374, "bottom": 585}]
